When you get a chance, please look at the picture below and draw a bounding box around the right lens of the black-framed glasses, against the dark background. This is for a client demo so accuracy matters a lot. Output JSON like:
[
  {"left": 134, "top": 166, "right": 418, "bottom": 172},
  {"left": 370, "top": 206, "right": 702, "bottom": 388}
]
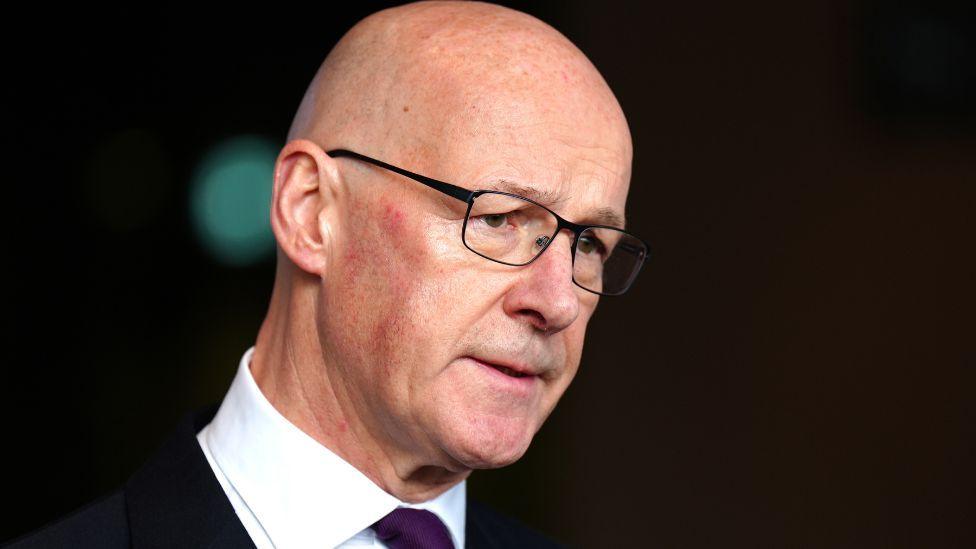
[{"left": 573, "top": 227, "right": 647, "bottom": 295}]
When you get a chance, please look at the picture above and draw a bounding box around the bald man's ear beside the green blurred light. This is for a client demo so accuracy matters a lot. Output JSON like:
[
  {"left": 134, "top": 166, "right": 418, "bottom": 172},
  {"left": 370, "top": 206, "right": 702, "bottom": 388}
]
[{"left": 271, "top": 139, "right": 341, "bottom": 276}]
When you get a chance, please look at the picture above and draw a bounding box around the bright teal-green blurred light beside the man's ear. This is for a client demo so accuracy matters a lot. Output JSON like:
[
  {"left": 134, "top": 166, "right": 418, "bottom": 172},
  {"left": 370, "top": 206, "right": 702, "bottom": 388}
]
[{"left": 190, "top": 136, "right": 278, "bottom": 266}]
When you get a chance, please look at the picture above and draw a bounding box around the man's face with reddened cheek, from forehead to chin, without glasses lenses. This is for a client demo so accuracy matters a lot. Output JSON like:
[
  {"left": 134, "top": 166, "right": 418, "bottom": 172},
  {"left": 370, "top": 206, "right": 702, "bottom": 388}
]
[{"left": 319, "top": 64, "right": 630, "bottom": 470}]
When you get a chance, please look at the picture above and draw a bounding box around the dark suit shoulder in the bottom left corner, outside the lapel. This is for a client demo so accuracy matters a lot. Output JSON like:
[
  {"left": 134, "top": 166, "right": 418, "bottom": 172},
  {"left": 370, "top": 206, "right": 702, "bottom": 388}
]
[{"left": 4, "top": 490, "right": 129, "bottom": 549}]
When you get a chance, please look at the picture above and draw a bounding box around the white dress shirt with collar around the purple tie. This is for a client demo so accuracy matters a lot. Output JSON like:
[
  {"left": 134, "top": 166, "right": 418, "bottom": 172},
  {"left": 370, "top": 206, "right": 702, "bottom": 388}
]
[{"left": 197, "top": 347, "right": 466, "bottom": 549}]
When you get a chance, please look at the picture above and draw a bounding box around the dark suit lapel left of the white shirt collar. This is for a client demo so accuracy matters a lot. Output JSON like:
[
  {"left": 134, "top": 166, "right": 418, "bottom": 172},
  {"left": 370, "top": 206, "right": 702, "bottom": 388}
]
[{"left": 125, "top": 406, "right": 254, "bottom": 549}]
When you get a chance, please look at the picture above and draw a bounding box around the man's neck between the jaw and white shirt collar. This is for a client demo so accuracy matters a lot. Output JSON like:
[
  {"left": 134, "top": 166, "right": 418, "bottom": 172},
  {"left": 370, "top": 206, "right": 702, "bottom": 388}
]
[{"left": 250, "top": 273, "right": 471, "bottom": 503}]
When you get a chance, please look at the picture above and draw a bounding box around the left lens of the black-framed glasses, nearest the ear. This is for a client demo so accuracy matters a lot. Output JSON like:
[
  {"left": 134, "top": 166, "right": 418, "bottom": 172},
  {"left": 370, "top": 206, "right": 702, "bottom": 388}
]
[{"left": 463, "top": 193, "right": 559, "bottom": 265}]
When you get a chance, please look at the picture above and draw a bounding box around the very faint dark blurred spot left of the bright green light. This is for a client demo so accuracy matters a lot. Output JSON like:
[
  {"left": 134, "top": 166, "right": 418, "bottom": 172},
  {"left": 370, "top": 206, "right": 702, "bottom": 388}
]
[{"left": 87, "top": 129, "right": 173, "bottom": 232}]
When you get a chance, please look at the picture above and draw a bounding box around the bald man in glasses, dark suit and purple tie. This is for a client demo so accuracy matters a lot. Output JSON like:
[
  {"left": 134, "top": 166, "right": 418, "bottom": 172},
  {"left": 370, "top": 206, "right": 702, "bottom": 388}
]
[{"left": 11, "top": 3, "right": 647, "bottom": 548}]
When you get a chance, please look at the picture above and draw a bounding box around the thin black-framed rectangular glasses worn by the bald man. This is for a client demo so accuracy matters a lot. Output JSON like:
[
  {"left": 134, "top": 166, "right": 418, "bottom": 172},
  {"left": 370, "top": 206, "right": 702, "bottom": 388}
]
[{"left": 326, "top": 149, "right": 648, "bottom": 295}]
